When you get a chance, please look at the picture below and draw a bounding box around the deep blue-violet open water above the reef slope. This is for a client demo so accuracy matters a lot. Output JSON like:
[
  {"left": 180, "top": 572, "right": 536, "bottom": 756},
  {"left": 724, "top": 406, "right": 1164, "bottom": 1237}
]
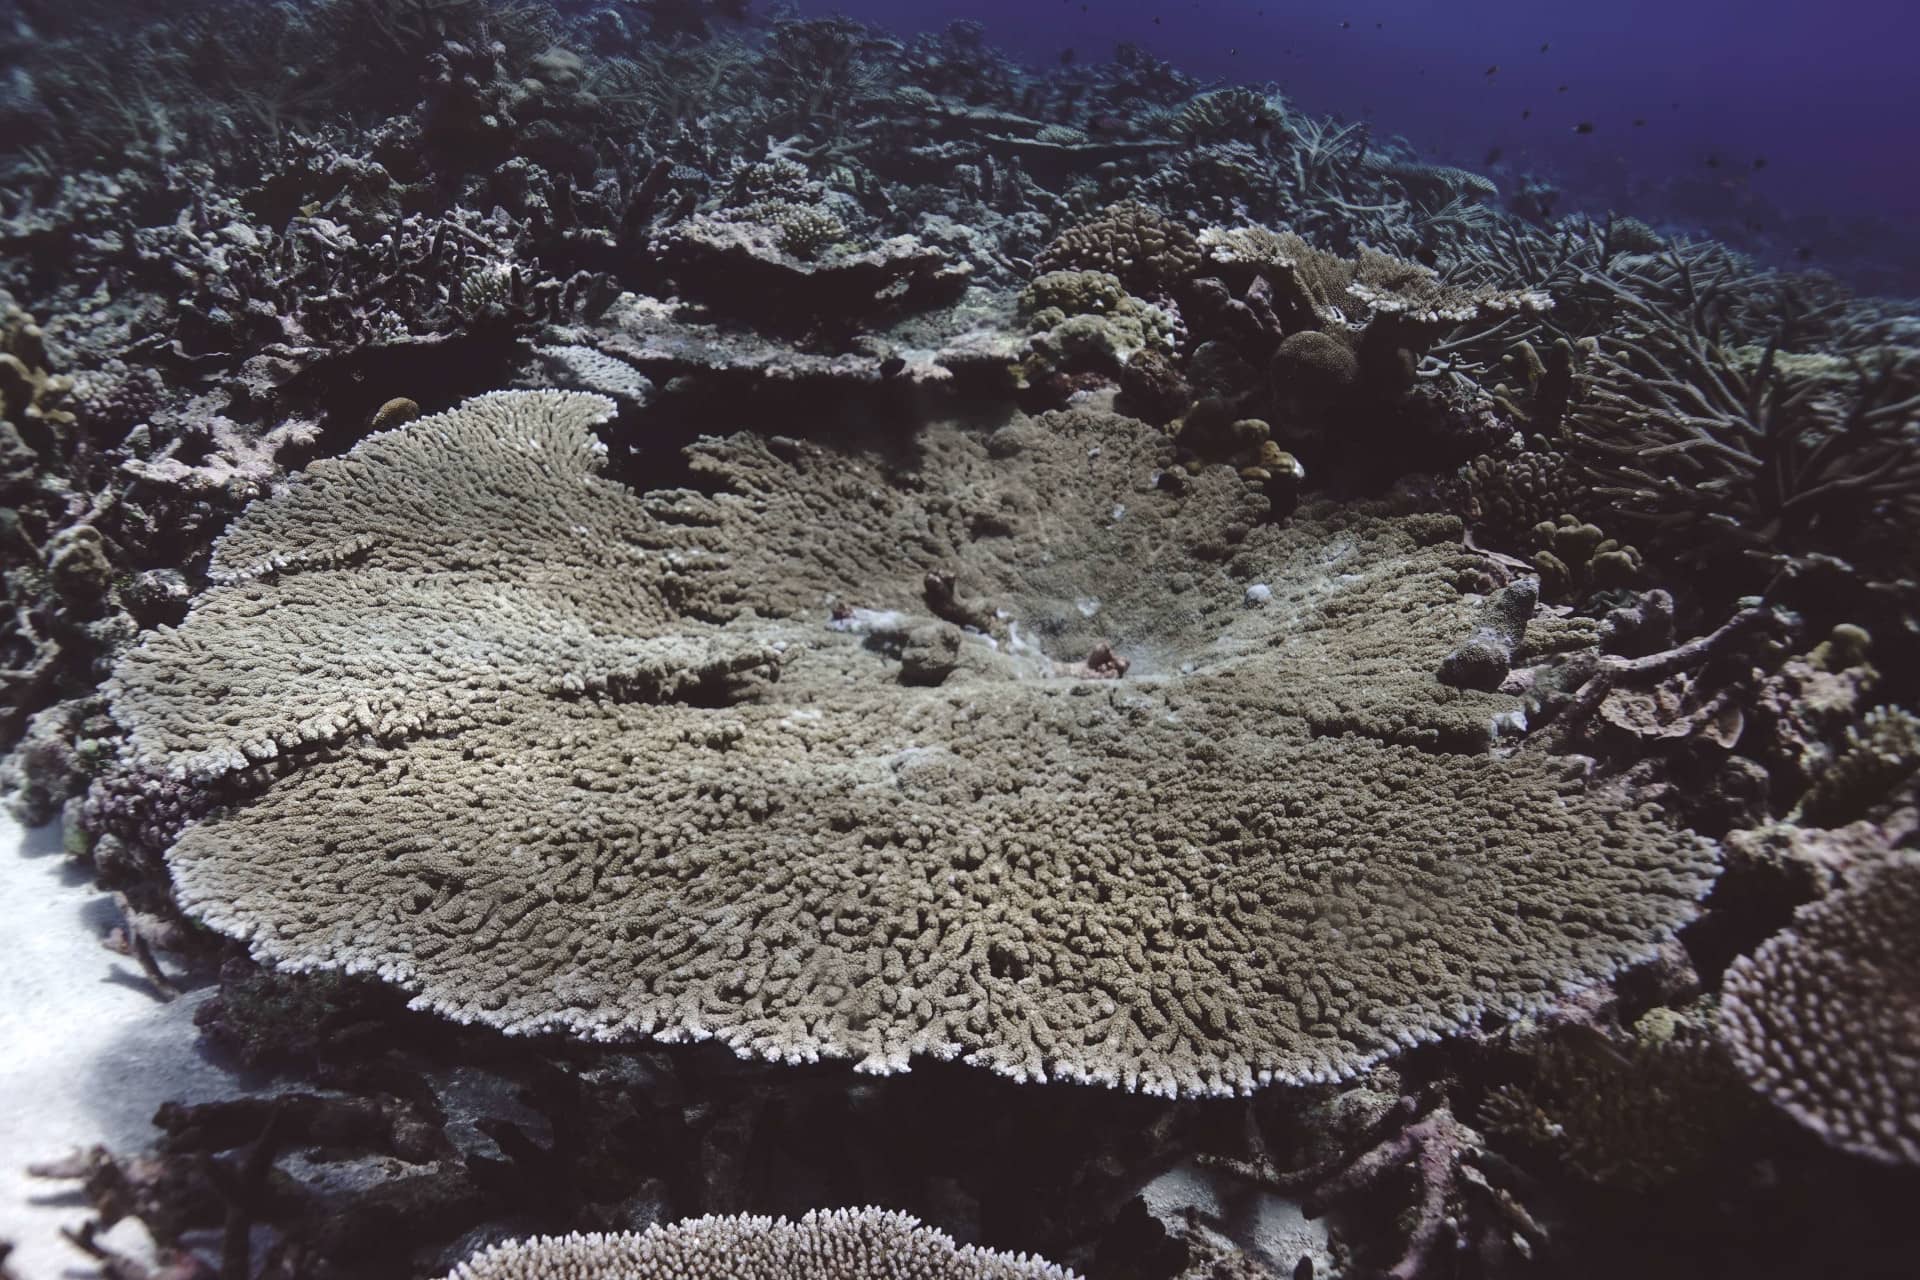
[{"left": 799, "top": 0, "right": 1920, "bottom": 292}]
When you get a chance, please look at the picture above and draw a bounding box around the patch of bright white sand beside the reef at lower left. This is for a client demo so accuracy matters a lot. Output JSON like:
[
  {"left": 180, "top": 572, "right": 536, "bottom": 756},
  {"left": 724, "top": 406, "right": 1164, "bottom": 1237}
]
[{"left": 0, "top": 814, "right": 242, "bottom": 1280}]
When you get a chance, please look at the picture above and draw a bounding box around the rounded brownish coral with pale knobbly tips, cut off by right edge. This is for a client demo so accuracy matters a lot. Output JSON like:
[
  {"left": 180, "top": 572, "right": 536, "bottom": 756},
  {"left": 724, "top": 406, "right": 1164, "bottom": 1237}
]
[{"left": 1720, "top": 850, "right": 1920, "bottom": 1165}]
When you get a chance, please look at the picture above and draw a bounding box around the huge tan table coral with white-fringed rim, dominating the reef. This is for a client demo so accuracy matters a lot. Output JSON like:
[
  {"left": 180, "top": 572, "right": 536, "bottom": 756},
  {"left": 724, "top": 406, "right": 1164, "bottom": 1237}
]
[{"left": 97, "top": 393, "right": 1713, "bottom": 1094}]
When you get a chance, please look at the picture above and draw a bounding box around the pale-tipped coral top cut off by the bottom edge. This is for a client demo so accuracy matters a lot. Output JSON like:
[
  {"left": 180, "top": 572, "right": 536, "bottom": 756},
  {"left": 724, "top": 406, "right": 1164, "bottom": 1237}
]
[{"left": 447, "top": 1209, "right": 1073, "bottom": 1280}]
